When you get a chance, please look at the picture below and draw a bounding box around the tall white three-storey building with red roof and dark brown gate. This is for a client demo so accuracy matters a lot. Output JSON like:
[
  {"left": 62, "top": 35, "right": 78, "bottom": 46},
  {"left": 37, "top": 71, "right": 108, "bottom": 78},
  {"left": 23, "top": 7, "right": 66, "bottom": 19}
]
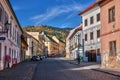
[{"left": 79, "top": 2, "right": 101, "bottom": 62}]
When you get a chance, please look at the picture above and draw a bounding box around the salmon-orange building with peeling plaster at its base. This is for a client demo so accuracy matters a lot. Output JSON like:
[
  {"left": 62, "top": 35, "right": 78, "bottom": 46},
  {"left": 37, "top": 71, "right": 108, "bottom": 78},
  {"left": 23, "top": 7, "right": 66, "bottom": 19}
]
[{"left": 99, "top": 0, "right": 120, "bottom": 69}]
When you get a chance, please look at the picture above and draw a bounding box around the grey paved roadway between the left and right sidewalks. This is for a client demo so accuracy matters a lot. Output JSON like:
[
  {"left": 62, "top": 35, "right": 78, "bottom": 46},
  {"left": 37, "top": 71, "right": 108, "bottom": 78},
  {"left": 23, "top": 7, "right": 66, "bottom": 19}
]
[{"left": 32, "top": 58, "right": 120, "bottom": 80}]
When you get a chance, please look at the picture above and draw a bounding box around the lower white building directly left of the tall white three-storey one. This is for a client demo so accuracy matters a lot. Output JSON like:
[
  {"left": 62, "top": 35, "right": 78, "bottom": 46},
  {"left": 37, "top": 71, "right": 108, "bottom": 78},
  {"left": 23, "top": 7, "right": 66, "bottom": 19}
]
[{"left": 66, "top": 25, "right": 83, "bottom": 59}]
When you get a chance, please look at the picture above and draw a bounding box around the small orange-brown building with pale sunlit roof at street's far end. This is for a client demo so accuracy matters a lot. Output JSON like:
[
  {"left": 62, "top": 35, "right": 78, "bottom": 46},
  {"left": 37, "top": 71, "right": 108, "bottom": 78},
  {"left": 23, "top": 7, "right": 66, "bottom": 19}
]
[{"left": 52, "top": 36, "right": 65, "bottom": 54}]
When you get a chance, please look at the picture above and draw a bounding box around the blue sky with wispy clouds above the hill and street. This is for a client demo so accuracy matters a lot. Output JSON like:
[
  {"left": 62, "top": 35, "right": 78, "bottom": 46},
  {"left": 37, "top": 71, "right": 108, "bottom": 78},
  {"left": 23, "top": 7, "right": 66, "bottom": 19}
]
[{"left": 10, "top": 0, "right": 95, "bottom": 28}]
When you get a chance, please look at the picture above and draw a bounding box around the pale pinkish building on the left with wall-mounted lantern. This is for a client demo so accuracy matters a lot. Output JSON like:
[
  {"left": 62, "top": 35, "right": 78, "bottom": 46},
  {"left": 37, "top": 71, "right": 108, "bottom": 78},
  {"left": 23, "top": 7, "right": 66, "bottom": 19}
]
[{"left": 0, "top": 0, "right": 23, "bottom": 69}]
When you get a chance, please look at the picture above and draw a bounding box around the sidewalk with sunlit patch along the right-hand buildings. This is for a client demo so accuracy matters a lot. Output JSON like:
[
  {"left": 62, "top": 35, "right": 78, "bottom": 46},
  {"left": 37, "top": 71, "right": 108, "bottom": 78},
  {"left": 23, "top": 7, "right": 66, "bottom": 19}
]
[{"left": 64, "top": 59, "right": 120, "bottom": 77}]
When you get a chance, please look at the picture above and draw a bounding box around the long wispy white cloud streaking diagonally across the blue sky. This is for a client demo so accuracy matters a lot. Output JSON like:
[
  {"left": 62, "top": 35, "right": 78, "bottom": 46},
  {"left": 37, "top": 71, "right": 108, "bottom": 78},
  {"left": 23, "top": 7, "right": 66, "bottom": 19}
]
[{"left": 30, "top": 4, "right": 83, "bottom": 25}]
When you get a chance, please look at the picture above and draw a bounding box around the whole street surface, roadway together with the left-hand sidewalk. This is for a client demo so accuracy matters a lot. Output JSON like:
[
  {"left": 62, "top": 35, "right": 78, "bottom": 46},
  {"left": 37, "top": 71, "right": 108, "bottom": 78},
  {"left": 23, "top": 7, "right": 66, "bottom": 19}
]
[{"left": 0, "top": 58, "right": 120, "bottom": 80}]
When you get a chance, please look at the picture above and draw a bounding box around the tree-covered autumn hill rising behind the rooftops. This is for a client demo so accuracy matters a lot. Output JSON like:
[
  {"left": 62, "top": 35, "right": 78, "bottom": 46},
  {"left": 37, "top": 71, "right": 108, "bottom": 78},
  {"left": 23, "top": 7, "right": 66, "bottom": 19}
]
[{"left": 23, "top": 25, "right": 72, "bottom": 42}]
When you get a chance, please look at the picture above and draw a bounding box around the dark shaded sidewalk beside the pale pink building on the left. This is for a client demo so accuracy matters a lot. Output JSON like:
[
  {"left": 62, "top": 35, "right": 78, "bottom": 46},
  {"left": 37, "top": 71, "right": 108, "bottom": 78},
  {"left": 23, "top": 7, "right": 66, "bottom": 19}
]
[{"left": 0, "top": 61, "right": 38, "bottom": 80}]
